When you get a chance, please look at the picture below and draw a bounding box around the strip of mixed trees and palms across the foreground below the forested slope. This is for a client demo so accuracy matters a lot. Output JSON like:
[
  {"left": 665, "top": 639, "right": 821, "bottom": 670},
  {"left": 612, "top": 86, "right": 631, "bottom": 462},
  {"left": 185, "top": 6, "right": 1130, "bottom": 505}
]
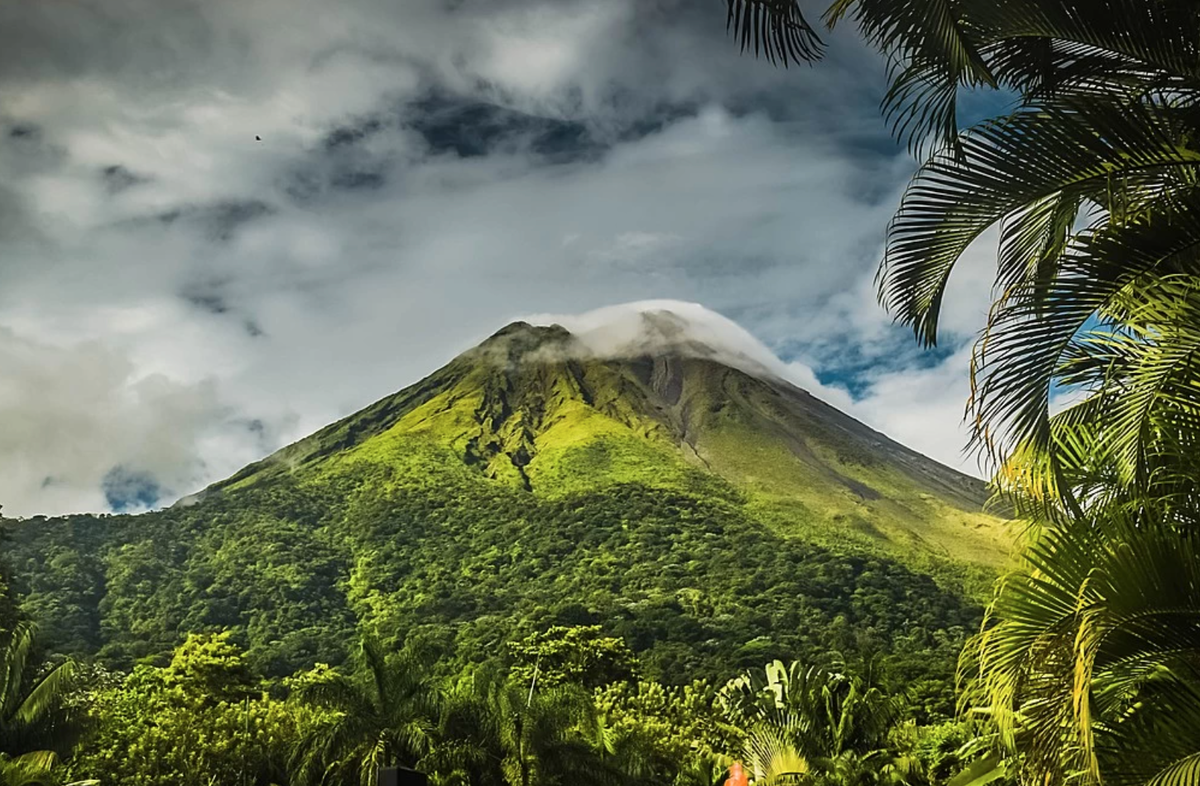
[{"left": 0, "top": 614, "right": 993, "bottom": 786}]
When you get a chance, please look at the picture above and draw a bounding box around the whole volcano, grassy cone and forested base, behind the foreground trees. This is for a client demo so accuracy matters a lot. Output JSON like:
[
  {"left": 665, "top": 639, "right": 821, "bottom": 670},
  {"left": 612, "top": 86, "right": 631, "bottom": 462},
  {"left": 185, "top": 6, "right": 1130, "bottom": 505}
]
[{"left": 4, "top": 323, "right": 1004, "bottom": 705}]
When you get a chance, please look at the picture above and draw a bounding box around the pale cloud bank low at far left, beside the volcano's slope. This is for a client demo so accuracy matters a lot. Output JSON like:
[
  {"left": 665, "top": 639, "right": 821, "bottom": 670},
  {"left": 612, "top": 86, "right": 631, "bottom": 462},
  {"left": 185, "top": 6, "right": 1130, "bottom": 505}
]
[{"left": 0, "top": 329, "right": 262, "bottom": 515}]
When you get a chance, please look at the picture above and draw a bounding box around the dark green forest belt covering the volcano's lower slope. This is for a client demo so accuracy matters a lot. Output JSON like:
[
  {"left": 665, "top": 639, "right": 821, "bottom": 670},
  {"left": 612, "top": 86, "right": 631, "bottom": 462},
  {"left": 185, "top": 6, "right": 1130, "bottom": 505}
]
[{"left": 4, "top": 482, "right": 983, "bottom": 718}]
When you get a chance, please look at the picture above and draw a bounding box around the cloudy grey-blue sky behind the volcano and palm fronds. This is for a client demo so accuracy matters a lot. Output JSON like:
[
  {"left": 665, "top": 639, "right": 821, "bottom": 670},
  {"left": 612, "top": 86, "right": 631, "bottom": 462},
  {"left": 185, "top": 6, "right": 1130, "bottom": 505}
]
[{"left": 0, "top": 0, "right": 989, "bottom": 515}]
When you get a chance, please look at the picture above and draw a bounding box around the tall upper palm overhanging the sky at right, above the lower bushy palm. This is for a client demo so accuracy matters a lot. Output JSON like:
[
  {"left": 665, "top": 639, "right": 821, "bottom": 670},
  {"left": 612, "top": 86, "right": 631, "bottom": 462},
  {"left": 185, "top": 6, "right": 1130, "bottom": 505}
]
[{"left": 730, "top": 0, "right": 1200, "bottom": 518}]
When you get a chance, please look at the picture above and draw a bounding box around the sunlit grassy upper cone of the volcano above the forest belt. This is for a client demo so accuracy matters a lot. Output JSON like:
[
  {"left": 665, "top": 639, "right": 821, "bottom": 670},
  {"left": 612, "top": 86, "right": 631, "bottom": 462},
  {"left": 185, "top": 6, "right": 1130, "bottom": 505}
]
[{"left": 209, "top": 323, "right": 1008, "bottom": 568}]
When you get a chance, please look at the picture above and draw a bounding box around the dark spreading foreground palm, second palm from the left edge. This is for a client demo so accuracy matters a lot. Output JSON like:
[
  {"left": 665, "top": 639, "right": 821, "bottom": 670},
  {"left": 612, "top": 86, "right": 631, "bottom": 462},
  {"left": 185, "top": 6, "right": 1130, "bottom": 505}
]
[{"left": 296, "top": 635, "right": 438, "bottom": 786}]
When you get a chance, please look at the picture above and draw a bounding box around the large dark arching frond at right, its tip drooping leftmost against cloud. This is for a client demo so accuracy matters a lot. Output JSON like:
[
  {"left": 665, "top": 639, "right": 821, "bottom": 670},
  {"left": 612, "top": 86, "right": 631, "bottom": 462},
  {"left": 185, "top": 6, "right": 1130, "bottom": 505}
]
[{"left": 880, "top": 101, "right": 1200, "bottom": 344}]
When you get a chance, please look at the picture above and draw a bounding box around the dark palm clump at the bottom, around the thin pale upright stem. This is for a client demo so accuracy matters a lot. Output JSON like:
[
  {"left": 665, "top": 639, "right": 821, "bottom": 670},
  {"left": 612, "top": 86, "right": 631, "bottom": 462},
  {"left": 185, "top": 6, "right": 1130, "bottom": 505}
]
[{"left": 426, "top": 676, "right": 623, "bottom": 786}]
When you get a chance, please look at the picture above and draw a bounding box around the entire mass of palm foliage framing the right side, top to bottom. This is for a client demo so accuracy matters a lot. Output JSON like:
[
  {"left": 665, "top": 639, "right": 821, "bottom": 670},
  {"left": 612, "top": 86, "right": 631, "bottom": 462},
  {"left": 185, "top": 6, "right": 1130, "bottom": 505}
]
[{"left": 731, "top": 6, "right": 1200, "bottom": 784}]
